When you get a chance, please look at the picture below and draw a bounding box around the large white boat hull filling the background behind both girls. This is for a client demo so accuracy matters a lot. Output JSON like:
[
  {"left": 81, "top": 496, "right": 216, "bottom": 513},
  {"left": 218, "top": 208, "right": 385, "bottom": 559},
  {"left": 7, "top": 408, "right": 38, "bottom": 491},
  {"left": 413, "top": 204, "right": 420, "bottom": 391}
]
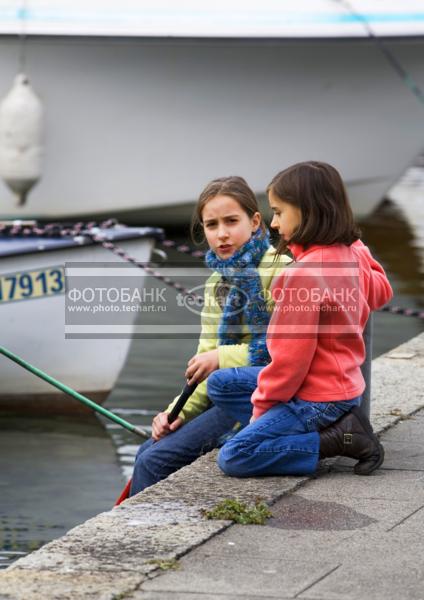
[{"left": 0, "top": 37, "right": 424, "bottom": 223}]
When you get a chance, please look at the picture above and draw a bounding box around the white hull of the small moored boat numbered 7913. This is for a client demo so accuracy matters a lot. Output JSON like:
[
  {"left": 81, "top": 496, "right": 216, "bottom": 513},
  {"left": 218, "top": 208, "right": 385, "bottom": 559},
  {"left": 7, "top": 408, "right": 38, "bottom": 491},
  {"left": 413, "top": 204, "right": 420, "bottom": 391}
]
[{"left": 0, "top": 233, "right": 154, "bottom": 412}]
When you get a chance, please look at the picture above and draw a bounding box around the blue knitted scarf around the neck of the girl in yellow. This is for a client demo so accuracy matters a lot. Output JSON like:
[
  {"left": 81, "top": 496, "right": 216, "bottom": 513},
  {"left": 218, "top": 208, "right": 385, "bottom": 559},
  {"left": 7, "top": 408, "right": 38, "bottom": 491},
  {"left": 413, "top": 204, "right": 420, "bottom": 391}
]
[{"left": 205, "top": 229, "right": 271, "bottom": 366}]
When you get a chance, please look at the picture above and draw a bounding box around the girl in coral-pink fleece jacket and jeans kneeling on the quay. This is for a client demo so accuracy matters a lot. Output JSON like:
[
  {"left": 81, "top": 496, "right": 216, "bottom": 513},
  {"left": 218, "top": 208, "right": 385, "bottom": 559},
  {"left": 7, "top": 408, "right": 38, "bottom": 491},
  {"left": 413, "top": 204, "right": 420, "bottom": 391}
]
[{"left": 212, "top": 161, "right": 392, "bottom": 477}]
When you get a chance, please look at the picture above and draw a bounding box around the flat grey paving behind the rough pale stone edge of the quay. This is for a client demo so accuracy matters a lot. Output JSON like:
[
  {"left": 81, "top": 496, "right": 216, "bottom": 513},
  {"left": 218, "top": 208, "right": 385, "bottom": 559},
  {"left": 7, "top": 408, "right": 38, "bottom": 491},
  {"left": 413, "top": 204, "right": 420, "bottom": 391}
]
[{"left": 132, "top": 411, "right": 424, "bottom": 600}]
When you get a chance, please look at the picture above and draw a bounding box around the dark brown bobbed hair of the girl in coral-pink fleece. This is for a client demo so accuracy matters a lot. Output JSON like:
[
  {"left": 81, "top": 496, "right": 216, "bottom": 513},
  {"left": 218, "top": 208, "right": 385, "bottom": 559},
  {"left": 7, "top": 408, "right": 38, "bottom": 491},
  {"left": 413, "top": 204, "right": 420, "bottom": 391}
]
[{"left": 267, "top": 160, "right": 361, "bottom": 254}]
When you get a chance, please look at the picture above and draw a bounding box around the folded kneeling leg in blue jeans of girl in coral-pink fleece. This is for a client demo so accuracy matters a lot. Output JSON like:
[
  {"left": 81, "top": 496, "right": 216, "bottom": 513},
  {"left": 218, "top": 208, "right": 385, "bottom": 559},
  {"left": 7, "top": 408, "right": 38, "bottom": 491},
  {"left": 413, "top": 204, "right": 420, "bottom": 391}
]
[{"left": 218, "top": 397, "right": 361, "bottom": 477}]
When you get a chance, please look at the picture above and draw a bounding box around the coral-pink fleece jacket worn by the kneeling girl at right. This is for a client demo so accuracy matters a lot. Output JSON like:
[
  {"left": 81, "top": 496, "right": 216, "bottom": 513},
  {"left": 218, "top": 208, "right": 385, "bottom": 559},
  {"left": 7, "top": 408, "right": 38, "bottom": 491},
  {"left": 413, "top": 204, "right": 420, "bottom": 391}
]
[{"left": 252, "top": 240, "right": 393, "bottom": 418}]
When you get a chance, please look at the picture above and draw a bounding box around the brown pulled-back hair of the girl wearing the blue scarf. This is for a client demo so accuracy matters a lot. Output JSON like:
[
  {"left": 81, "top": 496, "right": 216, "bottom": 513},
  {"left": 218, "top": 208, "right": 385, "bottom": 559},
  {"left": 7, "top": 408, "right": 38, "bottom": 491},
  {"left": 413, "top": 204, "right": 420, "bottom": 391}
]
[{"left": 191, "top": 175, "right": 266, "bottom": 242}]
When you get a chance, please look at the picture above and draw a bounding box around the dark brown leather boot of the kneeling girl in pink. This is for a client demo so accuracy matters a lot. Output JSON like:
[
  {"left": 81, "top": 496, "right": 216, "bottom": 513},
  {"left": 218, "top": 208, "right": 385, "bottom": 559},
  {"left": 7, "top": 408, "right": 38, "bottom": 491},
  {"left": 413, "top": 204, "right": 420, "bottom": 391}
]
[{"left": 320, "top": 406, "right": 384, "bottom": 475}]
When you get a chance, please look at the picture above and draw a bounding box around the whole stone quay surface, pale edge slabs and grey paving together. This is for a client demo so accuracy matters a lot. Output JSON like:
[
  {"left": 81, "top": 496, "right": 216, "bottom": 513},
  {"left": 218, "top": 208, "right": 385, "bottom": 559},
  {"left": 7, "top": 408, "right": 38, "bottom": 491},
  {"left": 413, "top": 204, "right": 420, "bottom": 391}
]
[{"left": 0, "top": 334, "right": 424, "bottom": 600}]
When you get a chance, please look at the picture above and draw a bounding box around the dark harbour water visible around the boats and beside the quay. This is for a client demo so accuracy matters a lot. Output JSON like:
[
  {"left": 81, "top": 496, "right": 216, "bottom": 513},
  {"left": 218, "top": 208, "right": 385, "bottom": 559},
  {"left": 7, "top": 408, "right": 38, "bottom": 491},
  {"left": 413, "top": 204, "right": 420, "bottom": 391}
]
[{"left": 0, "top": 183, "right": 424, "bottom": 568}]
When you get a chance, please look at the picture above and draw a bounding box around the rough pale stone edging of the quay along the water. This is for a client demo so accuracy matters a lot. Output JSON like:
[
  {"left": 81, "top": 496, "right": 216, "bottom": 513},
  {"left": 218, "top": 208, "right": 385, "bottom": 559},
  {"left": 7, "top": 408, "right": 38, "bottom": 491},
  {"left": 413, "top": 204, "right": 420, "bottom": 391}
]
[{"left": 0, "top": 334, "right": 424, "bottom": 600}]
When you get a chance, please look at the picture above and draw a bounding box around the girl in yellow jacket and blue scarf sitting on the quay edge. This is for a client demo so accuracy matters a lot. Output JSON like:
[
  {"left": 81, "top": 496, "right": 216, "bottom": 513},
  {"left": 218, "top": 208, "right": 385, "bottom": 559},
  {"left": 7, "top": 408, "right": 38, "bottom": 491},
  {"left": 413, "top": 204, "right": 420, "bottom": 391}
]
[{"left": 130, "top": 177, "right": 290, "bottom": 496}]
